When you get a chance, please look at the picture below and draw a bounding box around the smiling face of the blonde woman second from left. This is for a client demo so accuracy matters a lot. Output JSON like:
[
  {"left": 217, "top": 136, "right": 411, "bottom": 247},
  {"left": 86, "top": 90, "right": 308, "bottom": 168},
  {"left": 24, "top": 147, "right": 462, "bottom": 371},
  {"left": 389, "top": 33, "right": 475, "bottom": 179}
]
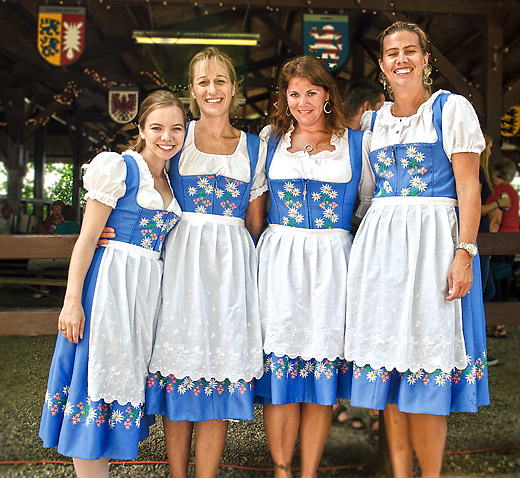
[{"left": 191, "top": 59, "right": 235, "bottom": 116}]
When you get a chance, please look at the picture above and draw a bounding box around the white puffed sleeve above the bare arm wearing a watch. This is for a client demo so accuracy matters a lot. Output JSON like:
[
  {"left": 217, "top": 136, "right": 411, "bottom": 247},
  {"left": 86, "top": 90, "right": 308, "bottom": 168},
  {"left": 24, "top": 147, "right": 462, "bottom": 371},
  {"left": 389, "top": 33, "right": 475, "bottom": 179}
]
[{"left": 442, "top": 95, "right": 486, "bottom": 159}]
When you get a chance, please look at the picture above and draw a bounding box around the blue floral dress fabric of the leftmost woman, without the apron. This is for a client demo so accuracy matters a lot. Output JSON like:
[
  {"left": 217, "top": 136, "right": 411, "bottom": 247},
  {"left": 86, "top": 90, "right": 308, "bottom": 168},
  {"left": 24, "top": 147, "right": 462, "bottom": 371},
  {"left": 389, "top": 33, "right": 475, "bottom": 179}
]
[{"left": 40, "top": 156, "right": 178, "bottom": 460}]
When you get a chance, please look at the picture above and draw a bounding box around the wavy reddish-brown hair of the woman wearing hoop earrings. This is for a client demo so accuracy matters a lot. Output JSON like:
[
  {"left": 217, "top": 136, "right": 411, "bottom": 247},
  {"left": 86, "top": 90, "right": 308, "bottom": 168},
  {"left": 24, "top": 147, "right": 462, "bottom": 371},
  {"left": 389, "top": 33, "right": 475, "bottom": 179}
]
[{"left": 271, "top": 55, "right": 347, "bottom": 136}]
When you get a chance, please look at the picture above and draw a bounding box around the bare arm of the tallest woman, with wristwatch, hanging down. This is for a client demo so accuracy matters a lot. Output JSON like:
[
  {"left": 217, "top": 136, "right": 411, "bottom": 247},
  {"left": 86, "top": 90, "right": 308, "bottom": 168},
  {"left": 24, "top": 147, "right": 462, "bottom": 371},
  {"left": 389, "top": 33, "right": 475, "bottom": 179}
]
[{"left": 446, "top": 153, "right": 481, "bottom": 301}]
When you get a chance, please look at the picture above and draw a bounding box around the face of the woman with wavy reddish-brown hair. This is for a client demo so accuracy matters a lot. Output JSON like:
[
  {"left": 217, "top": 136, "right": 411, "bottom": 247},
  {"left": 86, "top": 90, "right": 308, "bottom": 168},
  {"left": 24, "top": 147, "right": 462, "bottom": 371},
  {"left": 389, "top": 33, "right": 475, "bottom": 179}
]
[{"left": 287, "top": 76, "right": 330, "bottom": 126}]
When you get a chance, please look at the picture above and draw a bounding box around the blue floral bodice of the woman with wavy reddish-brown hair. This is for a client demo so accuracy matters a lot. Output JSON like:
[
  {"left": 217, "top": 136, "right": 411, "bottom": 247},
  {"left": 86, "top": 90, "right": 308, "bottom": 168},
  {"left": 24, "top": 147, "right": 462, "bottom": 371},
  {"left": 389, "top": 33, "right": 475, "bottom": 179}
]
[{"left": 266, "top": 130, "right": 363, "bottom": 231}]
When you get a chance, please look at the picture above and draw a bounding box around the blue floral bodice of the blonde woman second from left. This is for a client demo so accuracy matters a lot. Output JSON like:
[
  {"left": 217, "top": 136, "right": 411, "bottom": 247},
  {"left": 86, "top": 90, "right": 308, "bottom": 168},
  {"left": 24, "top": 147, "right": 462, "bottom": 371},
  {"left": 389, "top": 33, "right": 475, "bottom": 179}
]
[{"left": 169, "top": 125, "right": 260, "bottom": 219}]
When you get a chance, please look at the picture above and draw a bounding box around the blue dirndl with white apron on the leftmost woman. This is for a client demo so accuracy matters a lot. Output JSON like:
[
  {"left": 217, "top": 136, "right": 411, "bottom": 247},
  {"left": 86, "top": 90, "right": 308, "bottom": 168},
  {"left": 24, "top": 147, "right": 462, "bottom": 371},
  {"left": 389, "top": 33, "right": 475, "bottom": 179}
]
[{"left": 40, "top": 155, "right": 179, "bottom": 460}]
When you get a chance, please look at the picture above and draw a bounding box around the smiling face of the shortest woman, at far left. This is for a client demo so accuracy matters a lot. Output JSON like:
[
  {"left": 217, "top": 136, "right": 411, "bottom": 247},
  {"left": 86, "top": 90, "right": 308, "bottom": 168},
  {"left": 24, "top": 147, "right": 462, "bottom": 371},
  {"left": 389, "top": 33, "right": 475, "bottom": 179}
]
[{"left": 139, "top": 106, "right": 185, "bottom": 161}]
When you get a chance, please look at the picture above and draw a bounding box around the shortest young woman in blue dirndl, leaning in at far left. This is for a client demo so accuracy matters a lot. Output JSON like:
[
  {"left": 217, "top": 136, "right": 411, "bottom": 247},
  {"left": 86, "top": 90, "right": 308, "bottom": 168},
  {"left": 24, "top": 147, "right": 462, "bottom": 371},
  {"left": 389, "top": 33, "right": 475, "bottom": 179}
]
[{"left": 40, "top": 91, "right": 186, "bottom": 478}]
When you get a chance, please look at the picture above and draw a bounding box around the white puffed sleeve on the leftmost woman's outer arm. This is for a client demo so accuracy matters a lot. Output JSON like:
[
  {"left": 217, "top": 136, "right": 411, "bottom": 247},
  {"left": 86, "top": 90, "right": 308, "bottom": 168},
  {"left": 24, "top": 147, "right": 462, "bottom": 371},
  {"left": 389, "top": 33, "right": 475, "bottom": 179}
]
[{"left": 83, "top": 152, "right": 126, "bottom": 208}]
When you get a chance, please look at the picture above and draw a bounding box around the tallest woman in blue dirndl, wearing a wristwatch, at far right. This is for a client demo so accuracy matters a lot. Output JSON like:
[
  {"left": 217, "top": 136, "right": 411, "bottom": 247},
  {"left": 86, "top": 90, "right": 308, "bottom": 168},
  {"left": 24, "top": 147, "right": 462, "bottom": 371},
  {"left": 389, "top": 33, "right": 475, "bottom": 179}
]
[{"left": 345, "top": 22, "right": 489, "bottom": 477}]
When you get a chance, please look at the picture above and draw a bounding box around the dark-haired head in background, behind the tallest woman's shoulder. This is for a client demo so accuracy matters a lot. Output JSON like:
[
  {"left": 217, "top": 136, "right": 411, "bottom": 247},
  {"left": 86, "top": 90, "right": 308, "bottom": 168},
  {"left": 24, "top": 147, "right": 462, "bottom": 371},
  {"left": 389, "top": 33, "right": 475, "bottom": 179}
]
[{"left": 343, "top": 79, "right": 385, "bottom": 129}]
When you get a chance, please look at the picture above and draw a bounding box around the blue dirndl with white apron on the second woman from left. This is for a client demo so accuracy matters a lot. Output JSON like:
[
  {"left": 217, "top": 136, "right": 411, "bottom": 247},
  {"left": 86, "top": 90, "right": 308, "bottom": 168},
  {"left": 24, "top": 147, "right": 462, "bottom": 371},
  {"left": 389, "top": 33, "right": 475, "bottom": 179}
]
[{"left": 146, "top": 123, "right": 262, "bottom": 422}]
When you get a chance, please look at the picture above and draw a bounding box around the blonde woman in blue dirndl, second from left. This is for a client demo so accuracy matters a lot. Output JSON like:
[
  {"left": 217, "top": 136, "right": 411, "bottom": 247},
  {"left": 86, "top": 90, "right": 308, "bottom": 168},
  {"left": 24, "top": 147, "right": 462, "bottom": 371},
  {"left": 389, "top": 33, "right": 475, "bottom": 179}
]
[{"left": 144, "top": 48, "right": 267, "bottom": 477}]
